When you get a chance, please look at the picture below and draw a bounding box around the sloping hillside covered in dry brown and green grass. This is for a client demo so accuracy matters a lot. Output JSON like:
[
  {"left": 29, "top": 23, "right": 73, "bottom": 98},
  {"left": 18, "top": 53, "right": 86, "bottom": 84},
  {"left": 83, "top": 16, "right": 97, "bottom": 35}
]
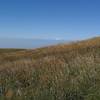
[{"left": 0, "top": 37, "right": 100, "bottom": 100}]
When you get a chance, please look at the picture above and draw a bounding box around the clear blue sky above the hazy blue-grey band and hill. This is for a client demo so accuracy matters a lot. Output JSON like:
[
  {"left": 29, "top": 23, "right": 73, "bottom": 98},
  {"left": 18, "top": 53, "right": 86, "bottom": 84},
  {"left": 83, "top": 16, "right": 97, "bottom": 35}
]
[{"left": 0, "top": 0, "right": 100, "bottom": 40}]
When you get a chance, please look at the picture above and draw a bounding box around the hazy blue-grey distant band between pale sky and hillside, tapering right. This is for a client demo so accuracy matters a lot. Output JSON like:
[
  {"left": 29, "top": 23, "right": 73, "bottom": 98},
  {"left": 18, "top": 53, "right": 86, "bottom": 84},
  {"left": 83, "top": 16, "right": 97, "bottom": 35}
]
[{"left": 0, "top": 38, "right": 67, "bottom": 48}]
